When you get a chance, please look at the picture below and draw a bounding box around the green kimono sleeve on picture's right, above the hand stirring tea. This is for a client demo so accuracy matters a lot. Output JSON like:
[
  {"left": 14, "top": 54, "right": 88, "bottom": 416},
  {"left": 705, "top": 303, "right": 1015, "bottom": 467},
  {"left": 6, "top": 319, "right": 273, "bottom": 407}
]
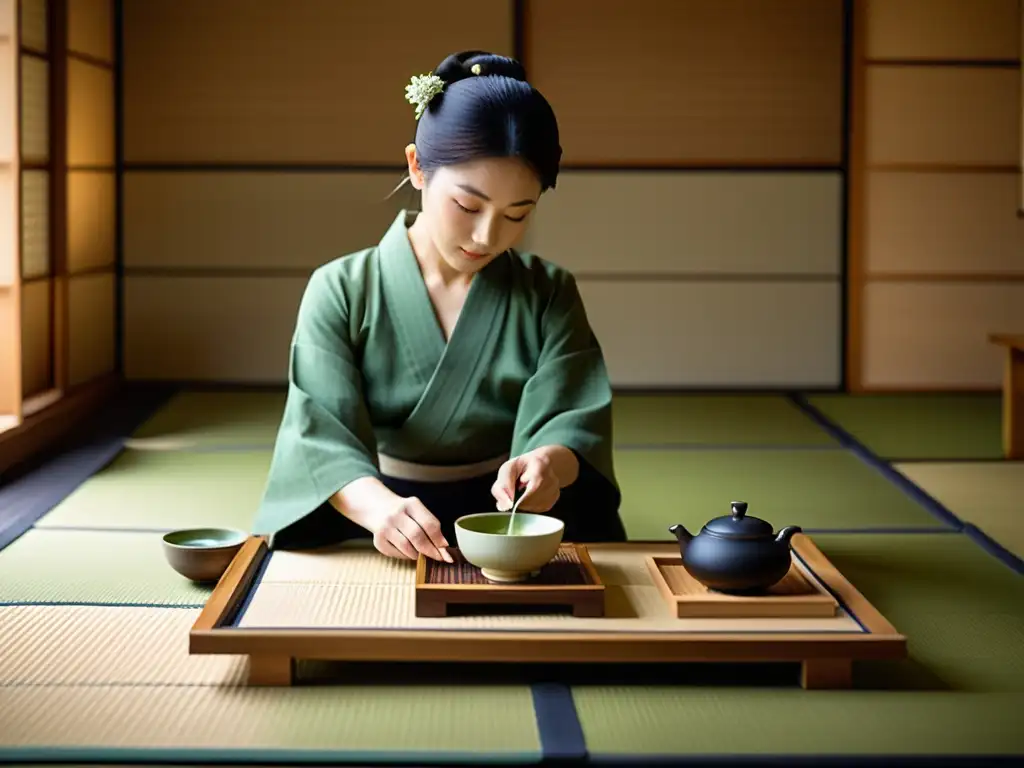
[{"left": 512, "top": 271, "right": 617, "bottom": 487}]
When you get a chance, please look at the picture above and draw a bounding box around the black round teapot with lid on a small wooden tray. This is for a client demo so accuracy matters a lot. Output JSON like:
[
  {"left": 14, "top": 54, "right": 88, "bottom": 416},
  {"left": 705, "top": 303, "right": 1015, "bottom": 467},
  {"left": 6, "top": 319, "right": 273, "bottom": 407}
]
[{"left": 669, "top": 502, "right": 801, "bottom": 594}]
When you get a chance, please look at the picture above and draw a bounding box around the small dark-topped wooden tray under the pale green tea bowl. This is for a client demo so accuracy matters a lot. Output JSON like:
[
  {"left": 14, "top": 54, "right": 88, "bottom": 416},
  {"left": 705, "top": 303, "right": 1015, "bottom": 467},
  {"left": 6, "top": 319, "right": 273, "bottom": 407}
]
[{"left": 416, "top": 544, "right": 604, "bottom": 617}]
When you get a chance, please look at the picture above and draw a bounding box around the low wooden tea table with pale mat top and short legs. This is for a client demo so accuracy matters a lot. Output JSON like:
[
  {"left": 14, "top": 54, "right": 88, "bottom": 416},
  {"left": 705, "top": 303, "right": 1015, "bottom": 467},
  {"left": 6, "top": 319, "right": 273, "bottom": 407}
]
[{"left": 189, "top": 535, "right": 906, "bottom": 688}]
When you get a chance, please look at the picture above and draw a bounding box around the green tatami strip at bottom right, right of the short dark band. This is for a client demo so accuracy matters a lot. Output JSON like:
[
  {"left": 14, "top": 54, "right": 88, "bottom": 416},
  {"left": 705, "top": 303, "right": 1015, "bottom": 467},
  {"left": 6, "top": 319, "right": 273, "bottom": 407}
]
[{"left": 572, "top": 686, "right": 1024, "bottom": 765}]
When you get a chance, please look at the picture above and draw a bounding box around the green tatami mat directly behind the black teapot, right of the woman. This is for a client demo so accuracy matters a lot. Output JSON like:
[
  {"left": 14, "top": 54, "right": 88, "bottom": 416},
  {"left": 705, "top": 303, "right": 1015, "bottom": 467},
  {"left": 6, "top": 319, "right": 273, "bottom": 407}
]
[{"left": 615, "top": 451, "right": 942, "bottom": 540}]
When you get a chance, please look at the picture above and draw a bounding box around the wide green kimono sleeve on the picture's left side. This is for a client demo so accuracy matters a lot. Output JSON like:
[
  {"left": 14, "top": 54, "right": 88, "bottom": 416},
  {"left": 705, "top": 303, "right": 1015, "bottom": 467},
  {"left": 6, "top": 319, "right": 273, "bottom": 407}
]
[{"left": 253, "top": 268, "right": 379, "bottom": 534}]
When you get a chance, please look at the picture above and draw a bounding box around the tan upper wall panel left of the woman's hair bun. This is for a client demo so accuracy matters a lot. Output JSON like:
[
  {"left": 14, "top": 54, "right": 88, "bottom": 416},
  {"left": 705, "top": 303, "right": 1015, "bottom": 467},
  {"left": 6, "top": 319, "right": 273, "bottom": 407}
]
[{"left": 123, "top": 0, "right": 513, "bottom": 166}]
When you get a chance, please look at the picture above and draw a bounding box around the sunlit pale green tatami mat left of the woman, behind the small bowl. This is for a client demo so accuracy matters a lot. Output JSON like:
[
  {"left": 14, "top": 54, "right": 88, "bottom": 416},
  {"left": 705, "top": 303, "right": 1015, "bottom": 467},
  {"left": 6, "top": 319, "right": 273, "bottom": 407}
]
[{"left": 37, "top": 450, "right": 271, "bottom": 530}]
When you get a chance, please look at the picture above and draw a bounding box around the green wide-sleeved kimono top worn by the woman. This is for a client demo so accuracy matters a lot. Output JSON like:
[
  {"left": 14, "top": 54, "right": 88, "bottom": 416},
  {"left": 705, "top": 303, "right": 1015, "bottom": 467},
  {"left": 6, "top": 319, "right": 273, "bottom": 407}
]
[{"left": 253, "top": 211, "right": 617, "bottom": 535}]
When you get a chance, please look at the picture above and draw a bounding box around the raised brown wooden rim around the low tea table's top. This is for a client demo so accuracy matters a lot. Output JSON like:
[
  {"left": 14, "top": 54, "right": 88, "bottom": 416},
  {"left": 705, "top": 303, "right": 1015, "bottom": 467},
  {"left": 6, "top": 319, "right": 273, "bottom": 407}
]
[{"left": 188, "top": 534, "right": 907, "bottom": 663}]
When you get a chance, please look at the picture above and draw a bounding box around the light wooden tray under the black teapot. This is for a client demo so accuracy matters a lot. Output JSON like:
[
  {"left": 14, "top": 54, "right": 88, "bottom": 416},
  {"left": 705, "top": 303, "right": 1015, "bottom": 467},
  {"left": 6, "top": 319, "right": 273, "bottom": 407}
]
[{"left": 645, "top": 556, "right": 839, "bottom": 618}]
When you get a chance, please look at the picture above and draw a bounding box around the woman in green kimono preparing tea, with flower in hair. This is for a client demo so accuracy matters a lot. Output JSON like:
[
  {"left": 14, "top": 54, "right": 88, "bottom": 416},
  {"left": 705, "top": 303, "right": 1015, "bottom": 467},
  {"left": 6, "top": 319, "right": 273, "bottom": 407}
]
[{"left": 254, "top": 51, "right": 626, "bottom": 560}]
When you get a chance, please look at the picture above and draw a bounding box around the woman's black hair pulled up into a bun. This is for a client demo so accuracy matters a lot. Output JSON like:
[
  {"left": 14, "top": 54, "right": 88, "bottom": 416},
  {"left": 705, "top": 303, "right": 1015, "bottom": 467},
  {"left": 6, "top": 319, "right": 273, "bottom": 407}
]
[{"left": 415, "top": 50, "right": 562, "bottom": 191}]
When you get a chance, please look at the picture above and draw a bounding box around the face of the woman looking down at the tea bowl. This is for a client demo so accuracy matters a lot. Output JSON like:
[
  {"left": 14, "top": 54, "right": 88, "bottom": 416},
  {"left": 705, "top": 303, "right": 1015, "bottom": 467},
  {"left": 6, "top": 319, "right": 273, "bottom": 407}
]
[{"left": 410, "top": 147, "right": 541, "bottom": 273}]
